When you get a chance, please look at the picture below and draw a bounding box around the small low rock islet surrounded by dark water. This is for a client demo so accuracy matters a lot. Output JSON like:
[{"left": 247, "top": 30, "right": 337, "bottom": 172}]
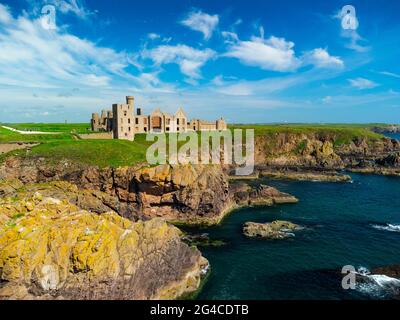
[{"left": 243, "top": 220, "right": 300, "bottom": 240}]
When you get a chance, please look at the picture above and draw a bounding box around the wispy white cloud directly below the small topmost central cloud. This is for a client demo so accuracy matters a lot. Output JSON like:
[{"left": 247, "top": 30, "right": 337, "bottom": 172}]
[{"left": 142, "top": 44, "right": 215, "bottom": 79}]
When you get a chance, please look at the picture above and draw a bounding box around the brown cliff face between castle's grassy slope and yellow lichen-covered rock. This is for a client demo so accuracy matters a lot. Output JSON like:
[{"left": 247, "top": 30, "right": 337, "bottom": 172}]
[{"left": 0, "top": 158, "right": 233, "bottom": 224}]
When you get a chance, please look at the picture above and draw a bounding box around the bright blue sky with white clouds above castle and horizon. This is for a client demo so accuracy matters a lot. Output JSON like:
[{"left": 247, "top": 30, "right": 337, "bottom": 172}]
[{"left": 0, "top": 0, "right": 400, "bottom": 123}]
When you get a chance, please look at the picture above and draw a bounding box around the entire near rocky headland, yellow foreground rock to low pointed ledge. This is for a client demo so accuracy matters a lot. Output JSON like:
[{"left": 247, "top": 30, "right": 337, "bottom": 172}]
[{"left": 0, "top": 159, "right": 298, "bottom": 300}]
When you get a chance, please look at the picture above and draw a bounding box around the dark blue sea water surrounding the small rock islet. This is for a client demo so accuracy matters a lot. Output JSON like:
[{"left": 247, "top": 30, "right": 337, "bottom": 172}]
[{"left": 189, "top": 175, "right": 400, "bottom": 299}]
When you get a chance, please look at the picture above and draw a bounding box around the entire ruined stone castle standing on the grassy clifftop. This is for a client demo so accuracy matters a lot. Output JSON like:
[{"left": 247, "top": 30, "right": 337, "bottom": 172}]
[{"left": 91, "top": 96, "right": 227, "bottom": 140}]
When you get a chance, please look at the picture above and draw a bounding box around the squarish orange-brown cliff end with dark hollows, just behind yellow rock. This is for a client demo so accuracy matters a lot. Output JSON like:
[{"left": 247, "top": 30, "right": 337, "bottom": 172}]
[{"left": 131, "top": 165, "right": 232, "bottom": 224}]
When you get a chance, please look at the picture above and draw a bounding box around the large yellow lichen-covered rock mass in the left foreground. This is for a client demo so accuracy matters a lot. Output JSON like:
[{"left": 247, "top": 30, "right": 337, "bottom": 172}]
[{"left": 0, "top": 193, "right": 208, "bottom": 299}]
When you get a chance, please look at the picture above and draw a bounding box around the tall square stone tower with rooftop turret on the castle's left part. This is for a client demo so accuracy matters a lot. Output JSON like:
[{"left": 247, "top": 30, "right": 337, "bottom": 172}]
[{"left": 113, "top": 96, "right": 135, "bottom": 141}]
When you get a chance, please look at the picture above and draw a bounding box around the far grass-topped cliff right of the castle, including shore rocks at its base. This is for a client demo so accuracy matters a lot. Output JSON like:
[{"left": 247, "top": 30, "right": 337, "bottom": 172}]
[{"left": 250, "top": 133, "right": 400, "bottom": 181}]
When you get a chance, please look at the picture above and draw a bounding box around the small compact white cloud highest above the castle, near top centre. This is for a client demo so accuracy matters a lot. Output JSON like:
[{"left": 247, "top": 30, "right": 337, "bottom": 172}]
[{"left": 181, "top": 11, "right": 219, "bottom": 40}]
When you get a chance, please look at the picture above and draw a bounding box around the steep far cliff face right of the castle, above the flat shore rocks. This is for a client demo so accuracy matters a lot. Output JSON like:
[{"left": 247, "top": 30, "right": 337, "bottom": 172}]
[{"left": 255, "top": 133, "right": 400, "bottom": 174}]
